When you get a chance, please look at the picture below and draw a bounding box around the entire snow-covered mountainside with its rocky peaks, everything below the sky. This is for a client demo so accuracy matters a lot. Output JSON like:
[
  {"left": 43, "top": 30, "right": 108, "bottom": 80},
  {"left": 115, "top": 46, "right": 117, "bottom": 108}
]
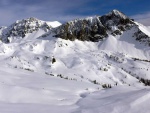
[{"left": 0, "top": 10, "right": 150, "bottom": 113}]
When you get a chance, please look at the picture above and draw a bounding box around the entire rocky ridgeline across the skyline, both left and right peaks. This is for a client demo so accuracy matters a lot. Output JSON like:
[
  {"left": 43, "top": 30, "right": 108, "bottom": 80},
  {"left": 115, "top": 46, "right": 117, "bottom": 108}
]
[{"left": 0, "top": 10, "right": 150, "bottom": 46}]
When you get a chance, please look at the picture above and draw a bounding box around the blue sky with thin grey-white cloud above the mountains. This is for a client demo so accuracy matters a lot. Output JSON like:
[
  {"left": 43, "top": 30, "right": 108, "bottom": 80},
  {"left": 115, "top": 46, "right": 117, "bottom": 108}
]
[{"left": 0, "top": 0, "right": 150, "bottom": 26}]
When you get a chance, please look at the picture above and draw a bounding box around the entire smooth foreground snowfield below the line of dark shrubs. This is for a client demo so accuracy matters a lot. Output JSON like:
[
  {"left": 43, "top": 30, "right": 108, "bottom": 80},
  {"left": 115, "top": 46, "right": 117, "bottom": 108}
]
[{"left": 0, "top": 66, "right": 150, "bottom": 113}]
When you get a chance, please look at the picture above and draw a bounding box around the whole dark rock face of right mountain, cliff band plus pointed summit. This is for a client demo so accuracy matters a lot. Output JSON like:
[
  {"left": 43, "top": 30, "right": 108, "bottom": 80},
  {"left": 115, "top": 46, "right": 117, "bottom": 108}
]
[{"left": 53, "top": 10, "right": 134, "bottom": 42}]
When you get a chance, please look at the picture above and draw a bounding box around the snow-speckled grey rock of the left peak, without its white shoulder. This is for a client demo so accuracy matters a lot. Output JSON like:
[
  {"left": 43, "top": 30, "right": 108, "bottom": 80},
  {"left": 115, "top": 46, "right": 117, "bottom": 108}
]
[{"left": 1, "top": 17, "right": 52, "bottom": 43}]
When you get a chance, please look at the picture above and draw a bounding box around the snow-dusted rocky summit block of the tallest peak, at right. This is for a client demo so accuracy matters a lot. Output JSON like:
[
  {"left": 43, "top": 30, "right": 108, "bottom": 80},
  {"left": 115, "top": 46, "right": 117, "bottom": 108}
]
[{"left": 101, "top": 10, "right": 135, "bottom": 35}]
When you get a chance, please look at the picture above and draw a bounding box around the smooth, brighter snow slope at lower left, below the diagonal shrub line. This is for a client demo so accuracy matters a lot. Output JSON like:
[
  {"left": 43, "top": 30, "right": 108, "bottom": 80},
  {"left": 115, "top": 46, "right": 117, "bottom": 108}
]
[{"left": 0, "top": 66, "right": 100, "bottom": 113}]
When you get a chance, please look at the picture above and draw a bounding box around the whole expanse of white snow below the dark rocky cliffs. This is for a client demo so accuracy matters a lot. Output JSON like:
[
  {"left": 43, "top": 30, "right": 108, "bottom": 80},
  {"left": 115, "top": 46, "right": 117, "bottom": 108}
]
[{"left": 0, "top": 18, "right": 150, "bottom": 113}]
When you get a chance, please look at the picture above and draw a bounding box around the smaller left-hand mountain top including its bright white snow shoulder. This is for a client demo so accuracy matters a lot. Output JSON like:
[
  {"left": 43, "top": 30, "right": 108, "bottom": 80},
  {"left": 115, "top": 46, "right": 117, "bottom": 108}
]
[{"left": 0, "top": 17, "right": 61, "bottom": 43}]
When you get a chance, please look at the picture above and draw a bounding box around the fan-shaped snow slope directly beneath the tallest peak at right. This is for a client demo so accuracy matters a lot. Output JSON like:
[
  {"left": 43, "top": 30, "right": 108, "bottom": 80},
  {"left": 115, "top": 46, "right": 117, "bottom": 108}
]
[{"left": 99, "top": 26, "right": 150, "bottom": 59}]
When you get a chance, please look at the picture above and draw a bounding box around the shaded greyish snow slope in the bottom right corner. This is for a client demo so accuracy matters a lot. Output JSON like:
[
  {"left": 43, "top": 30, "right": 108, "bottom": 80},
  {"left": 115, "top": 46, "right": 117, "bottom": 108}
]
[{"left": 75, "top": 87, "right": 150, "bottom": 113}]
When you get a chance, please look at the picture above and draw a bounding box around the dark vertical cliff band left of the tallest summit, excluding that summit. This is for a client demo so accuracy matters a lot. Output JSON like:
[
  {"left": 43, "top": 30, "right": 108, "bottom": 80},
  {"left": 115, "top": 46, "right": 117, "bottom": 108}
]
[{"left": 55, "top": 17, "right": 107, "bottom": 41}]
